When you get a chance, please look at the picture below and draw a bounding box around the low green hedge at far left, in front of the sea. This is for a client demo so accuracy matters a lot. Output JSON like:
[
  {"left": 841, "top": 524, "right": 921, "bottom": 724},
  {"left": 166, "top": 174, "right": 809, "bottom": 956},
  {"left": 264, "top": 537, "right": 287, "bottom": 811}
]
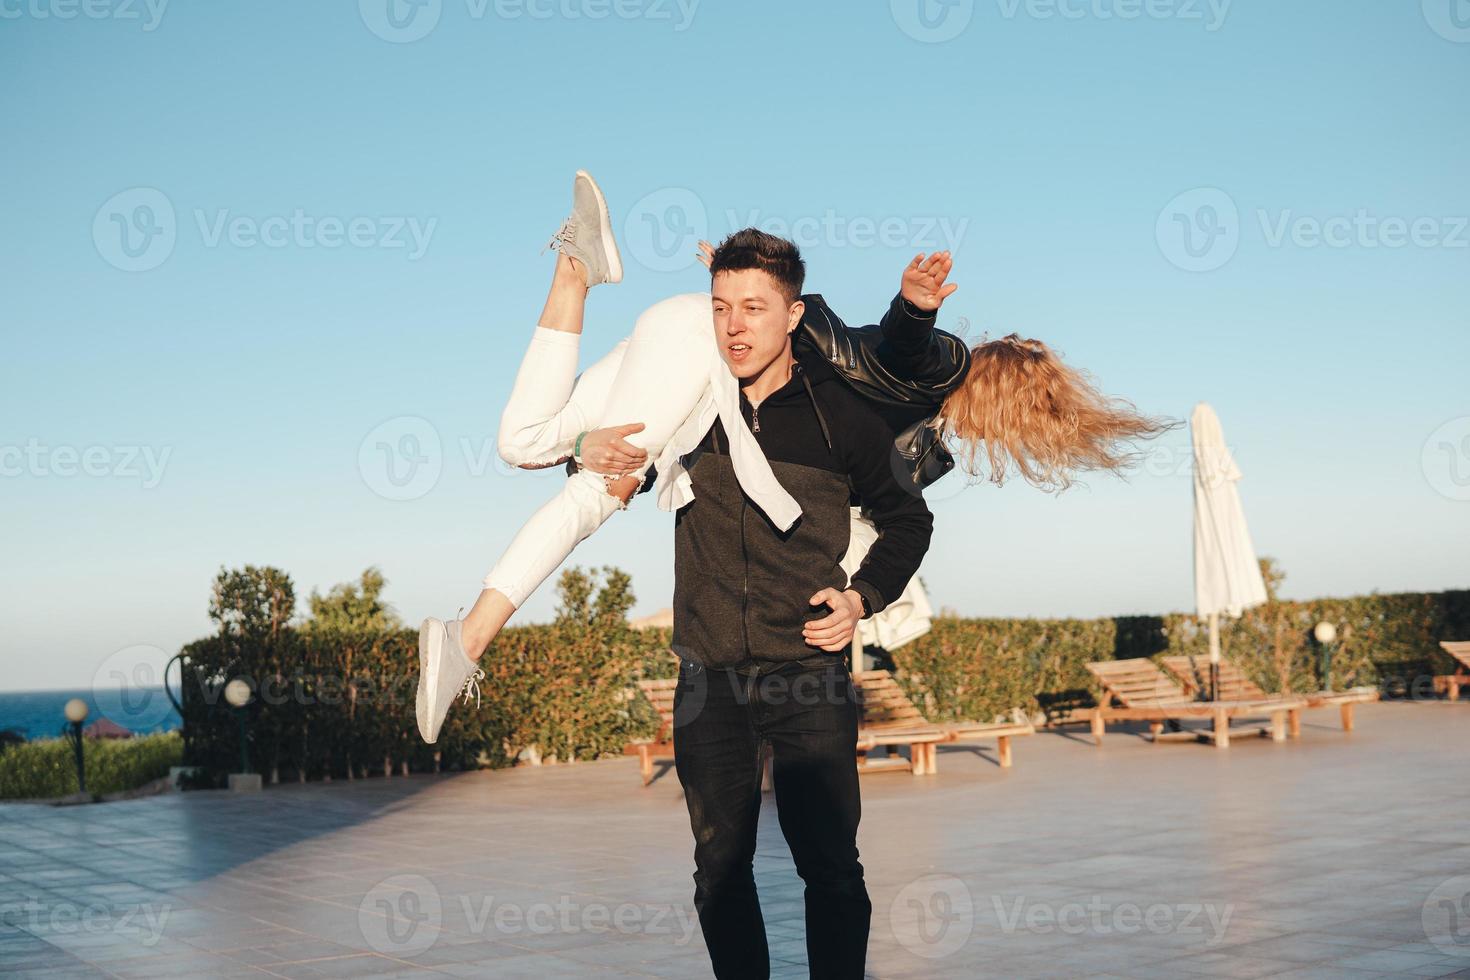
[{"left": 0, "top": 732, "right": 184, "bottom": 799}]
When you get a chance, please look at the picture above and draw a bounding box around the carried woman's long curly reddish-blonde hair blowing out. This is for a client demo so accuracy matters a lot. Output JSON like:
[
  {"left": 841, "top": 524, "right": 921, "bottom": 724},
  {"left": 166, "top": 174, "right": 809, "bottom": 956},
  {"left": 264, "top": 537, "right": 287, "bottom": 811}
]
[{"left": 933, "top": 334, "right": 1179, "bottom": 491}]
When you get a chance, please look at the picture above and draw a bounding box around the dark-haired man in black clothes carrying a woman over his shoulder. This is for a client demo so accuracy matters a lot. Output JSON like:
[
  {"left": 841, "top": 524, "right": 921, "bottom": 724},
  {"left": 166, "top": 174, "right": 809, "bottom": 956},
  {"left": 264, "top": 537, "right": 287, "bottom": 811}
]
[{"left": 673, "top": 229, "right": 933, "bottom": 979}]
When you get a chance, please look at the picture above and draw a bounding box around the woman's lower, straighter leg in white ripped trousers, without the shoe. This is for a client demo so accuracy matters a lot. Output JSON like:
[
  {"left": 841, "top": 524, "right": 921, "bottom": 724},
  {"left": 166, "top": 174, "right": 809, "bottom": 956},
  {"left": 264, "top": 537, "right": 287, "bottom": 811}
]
[{"left": 462, "top": 294, "right": 716, "bottom": 660}]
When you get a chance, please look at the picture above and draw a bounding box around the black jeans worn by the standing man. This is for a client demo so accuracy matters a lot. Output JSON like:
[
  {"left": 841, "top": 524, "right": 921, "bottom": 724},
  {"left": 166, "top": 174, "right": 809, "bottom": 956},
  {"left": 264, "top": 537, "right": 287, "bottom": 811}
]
[{"left": 673, "top": 655, "right": 873, "bottom": 980}]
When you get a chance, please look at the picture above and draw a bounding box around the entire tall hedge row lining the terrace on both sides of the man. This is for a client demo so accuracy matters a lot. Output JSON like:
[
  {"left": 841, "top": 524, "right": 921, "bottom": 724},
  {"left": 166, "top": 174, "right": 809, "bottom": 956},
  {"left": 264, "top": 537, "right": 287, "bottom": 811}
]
[{"left": 174, "top": 561, "right": 1470, "bottom": 785}]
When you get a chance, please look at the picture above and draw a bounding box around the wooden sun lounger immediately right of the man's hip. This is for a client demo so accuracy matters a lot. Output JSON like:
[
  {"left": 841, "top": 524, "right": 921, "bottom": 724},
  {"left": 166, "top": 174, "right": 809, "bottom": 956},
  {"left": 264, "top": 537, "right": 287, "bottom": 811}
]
[{"left": 853, "top": 670, "right": 1036, "bottom": 776}]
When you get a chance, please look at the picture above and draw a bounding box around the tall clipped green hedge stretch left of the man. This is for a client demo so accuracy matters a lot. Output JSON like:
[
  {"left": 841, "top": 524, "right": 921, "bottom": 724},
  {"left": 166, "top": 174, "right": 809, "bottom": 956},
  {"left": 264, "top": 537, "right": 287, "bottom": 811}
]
[{"left": 174, "top": 569, "right": 673, "bottom": 786}]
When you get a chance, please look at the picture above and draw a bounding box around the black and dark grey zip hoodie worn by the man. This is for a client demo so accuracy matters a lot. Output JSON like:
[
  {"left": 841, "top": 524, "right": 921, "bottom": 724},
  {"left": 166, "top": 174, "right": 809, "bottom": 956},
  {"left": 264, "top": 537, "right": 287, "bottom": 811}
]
[{"left": 673, "top": 344, "right": 933, "bottom": 667}]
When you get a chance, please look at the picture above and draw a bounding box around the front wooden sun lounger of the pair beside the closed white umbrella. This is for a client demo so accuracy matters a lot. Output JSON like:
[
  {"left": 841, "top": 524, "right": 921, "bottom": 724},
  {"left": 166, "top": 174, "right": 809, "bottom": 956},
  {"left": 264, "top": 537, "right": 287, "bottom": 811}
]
[{"left": 1088, "top": 657, "right": 1307, "bottom": 748}]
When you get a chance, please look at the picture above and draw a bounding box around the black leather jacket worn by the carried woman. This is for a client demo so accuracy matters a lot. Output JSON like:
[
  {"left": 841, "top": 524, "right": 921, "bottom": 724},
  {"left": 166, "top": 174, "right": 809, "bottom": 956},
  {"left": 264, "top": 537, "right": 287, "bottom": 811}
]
[{"left": 797, "top": 294, "right": 970, "bottom": 488}]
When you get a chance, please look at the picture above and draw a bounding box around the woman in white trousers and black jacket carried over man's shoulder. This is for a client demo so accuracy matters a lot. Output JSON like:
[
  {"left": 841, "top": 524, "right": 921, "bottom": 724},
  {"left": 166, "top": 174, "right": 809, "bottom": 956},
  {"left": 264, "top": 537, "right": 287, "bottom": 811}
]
[{"left": 416, "top": 170, "right": 1166, "bottom": 742}]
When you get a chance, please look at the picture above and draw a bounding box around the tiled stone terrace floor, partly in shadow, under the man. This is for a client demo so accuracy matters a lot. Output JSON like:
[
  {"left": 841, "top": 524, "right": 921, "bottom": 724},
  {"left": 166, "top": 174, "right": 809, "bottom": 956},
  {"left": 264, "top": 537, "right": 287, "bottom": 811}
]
[{"left": 0, "top": 702, "right": 1470, "bottom": 980}]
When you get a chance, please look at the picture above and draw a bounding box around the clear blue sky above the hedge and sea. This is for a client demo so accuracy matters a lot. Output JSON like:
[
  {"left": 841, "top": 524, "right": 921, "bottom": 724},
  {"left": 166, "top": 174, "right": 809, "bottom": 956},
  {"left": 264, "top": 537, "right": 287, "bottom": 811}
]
[{"left": 0, "top": 0, "right": 1470, "bottom": 689}]
